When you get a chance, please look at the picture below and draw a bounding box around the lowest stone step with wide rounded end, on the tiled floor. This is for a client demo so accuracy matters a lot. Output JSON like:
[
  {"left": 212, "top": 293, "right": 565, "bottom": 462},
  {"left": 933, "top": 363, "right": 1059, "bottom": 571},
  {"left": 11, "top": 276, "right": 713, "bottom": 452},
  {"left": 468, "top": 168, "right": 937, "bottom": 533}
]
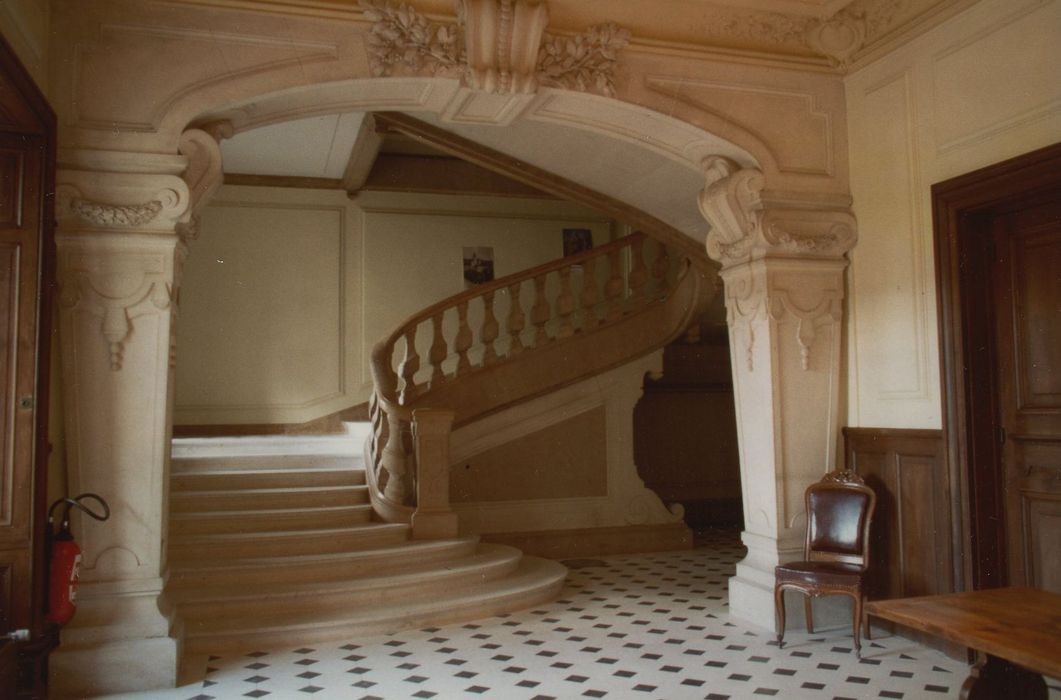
[{"left": 185, "top": 557, "right": 567, "bottom": 653}]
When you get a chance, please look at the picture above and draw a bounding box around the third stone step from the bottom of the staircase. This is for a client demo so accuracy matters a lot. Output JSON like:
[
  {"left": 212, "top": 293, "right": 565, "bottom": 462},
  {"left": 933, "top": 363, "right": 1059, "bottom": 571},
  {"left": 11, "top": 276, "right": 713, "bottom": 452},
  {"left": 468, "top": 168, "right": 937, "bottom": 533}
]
[{"left": 167, "top": 537, "right": 479, "bottom": 591}]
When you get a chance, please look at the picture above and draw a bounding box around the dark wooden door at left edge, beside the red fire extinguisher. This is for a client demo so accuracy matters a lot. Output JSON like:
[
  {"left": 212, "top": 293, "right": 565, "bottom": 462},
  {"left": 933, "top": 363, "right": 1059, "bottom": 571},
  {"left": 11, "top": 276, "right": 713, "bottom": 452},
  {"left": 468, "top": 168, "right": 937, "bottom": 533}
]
[{"left": 0, "top": 30, "right": 55, "bottom": 698}]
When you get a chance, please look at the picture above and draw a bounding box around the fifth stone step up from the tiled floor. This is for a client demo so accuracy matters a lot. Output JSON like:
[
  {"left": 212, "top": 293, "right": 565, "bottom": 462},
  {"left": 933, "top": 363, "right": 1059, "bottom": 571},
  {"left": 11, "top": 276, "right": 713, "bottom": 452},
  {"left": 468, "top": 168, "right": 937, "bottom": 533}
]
[{"left": 170, "top": 504, "right": 372, "bottom": 542}]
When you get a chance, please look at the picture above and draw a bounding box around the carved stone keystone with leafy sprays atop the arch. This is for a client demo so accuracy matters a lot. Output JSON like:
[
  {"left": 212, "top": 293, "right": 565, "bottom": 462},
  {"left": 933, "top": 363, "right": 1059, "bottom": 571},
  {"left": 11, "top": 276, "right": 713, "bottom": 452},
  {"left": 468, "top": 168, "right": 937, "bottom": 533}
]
[{"left": 360, "top": 0, "right": 630, "bottom": 97}]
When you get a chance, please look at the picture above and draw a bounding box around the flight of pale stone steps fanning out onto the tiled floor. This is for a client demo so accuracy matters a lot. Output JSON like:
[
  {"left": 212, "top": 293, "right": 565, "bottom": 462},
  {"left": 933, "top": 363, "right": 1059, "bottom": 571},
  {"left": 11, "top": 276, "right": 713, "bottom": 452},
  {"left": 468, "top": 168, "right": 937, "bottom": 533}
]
[{"left": 166, "top": 424, "right": 567, "bottom": 653}]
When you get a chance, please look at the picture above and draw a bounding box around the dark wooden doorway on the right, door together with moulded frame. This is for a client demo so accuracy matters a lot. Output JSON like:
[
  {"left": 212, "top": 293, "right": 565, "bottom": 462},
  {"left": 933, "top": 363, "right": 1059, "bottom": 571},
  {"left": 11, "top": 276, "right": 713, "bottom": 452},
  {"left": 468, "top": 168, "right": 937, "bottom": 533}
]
[{"left": 933, "top": 144, "right": 1061, "bottom": 592}]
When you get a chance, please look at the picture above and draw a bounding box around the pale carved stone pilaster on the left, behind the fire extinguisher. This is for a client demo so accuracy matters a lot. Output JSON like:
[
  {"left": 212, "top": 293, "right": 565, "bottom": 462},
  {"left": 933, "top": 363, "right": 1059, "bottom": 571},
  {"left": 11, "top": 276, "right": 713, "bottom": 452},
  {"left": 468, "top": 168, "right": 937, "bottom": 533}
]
[{"left": 51, "top": 133, "right": 220, "bottom": 695}]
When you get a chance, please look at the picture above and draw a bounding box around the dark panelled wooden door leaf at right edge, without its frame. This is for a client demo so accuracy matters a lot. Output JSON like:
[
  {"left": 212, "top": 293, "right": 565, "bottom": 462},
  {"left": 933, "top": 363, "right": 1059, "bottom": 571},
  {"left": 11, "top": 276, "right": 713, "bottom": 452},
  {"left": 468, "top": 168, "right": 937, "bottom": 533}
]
[{"left": 990, "top": 192, "right": 1061, "bottom": 593}]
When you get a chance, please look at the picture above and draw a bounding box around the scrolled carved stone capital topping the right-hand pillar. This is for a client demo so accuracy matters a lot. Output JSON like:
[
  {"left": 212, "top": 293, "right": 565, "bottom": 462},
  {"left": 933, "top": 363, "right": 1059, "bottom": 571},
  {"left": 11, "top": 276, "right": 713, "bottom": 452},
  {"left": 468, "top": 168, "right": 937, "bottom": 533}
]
[{"left": 699, "top": 156, "right": 857, "bottom": 266}]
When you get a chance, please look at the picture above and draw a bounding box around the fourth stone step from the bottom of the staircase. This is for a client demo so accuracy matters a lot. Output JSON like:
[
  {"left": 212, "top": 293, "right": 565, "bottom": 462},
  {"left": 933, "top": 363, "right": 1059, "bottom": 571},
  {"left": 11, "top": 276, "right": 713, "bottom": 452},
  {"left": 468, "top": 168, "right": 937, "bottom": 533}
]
[{"left": 170, "top": 523, "right": 408, "bottom": 565}]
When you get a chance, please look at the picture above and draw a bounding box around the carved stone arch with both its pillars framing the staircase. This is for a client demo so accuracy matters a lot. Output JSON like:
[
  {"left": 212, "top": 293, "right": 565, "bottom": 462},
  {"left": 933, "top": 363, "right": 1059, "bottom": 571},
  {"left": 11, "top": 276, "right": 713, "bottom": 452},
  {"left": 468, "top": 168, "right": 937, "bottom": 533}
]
[{"left": 53, "top": 2, "right": 855, "bottom": 685}]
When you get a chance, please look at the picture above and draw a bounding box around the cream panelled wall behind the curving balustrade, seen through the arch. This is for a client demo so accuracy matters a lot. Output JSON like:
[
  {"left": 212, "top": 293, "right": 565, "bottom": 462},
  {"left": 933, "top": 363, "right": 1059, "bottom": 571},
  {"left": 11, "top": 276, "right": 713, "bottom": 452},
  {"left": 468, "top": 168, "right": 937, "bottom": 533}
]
[{"left": 174, "top": 186, "right": 611, "bottom": 424}]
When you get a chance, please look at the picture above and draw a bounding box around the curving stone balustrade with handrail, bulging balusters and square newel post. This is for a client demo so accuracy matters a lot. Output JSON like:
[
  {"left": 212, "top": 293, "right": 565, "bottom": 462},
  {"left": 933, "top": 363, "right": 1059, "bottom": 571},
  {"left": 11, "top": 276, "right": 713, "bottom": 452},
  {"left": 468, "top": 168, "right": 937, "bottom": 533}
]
[{"left": 365, "top": 233, "right": 710, "bottom": 538}]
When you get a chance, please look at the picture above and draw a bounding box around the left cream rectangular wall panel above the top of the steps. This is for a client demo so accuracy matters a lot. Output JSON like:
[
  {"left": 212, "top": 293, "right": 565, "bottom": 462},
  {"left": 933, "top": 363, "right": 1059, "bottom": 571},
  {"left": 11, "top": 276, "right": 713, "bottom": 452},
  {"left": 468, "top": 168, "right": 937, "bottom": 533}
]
[{"left": 176, "top": 187, "right": 360, "bottom": 424}]
